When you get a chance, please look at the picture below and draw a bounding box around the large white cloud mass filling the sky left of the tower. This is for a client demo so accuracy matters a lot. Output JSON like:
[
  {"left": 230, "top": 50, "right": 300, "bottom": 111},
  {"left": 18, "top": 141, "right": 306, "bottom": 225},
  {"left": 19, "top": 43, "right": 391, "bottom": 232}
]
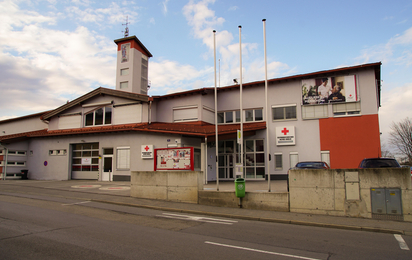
[{"left": 0, "top": 2, "right": 116, "bottom": 117}]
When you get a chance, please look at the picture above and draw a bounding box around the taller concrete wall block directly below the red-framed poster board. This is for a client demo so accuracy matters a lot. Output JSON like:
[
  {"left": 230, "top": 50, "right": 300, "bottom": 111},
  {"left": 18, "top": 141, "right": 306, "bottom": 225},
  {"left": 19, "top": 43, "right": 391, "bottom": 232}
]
[{"left": 130, "top": 171, "right": 203, "bottom": 203}]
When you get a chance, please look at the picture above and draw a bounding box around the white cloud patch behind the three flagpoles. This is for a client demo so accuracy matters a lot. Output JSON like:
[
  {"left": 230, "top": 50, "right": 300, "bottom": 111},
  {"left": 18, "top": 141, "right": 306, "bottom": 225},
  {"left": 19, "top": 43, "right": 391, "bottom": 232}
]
[{"left": 183, "top": 0, "right": 290, "bottom": 85}]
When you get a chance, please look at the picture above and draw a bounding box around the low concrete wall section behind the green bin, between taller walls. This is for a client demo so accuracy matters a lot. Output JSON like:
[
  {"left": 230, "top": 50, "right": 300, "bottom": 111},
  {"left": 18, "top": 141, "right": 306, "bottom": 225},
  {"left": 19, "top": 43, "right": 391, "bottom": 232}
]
[{"left": 199, "top": 190, "right": 289, "bottom": 212}]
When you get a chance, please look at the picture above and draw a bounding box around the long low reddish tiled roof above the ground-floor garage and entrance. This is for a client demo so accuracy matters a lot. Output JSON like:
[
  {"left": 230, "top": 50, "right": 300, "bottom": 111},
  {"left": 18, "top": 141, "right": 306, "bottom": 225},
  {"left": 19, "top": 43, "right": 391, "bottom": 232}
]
[{"left": 0, "top": 122, "right": 266, "bottom": 143}]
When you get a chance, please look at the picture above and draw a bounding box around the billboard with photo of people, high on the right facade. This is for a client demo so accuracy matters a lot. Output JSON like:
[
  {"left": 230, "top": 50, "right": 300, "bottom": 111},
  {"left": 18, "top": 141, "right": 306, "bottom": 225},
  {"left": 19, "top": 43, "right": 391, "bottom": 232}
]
[{"left": 302, "top": 75, "right": 358, "bottom": 105}]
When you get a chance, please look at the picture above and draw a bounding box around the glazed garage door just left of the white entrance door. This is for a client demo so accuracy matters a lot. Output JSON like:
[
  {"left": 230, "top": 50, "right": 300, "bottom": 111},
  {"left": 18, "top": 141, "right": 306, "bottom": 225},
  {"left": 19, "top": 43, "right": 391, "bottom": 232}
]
[{"left": 71, "top": 143, "right": 99, "bottom": 180}]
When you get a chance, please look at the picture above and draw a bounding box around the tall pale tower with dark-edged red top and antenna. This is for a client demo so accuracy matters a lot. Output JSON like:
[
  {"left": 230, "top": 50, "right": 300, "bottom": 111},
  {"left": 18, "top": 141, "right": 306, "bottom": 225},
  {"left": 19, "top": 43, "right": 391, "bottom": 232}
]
[{"left": 114, "top": 35, "right": 152, "bottom": 95}]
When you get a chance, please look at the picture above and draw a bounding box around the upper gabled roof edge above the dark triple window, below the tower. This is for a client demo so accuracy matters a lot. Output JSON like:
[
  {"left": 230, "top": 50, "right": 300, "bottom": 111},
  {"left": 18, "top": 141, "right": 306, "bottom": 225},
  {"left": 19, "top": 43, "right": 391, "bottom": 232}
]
[{"left": 41, "top": 87, "right": 149, "bottom": 120}]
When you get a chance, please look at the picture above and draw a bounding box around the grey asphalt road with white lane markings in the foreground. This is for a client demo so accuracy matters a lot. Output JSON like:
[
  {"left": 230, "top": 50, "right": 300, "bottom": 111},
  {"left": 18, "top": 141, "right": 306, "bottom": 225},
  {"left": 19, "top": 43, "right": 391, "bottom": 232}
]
[{"left": 0, "top": 187, "right": 412, "bottom": 260}]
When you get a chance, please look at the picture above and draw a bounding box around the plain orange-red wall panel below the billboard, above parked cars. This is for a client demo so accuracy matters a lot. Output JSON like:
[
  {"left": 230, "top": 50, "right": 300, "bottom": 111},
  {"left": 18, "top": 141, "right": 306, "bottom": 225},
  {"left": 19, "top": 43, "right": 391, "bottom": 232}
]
[{"left": 319, "top": 114, "right": 381, "bottom": 169}]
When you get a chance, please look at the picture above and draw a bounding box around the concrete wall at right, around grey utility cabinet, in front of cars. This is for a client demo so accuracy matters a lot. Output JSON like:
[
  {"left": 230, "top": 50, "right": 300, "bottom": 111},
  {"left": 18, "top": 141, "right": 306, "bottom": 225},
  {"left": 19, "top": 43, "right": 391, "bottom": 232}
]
[{"left": 289, "top": 168, "right": 412, "bottom": 221}]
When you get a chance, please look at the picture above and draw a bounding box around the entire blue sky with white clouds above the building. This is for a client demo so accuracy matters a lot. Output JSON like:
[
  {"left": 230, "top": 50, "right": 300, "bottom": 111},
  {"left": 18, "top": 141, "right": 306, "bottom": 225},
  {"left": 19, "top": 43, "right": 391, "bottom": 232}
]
[{"left": 0, "top": 0, "right": 412, "bottom": 154}]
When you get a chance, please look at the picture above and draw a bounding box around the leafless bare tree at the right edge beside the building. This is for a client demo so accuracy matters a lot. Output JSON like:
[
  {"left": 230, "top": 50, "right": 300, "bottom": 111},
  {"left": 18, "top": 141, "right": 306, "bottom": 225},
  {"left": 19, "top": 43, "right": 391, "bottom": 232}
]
[{"left": 389, "top": 117, "right": 412, "bottom": 163}]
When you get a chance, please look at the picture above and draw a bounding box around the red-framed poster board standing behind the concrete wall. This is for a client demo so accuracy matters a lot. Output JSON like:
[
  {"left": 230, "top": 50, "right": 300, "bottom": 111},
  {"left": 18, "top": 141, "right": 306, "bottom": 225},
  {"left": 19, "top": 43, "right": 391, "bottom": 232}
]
[{"left": 154, "top": 147, "right": 194, "bottom": 171}]
